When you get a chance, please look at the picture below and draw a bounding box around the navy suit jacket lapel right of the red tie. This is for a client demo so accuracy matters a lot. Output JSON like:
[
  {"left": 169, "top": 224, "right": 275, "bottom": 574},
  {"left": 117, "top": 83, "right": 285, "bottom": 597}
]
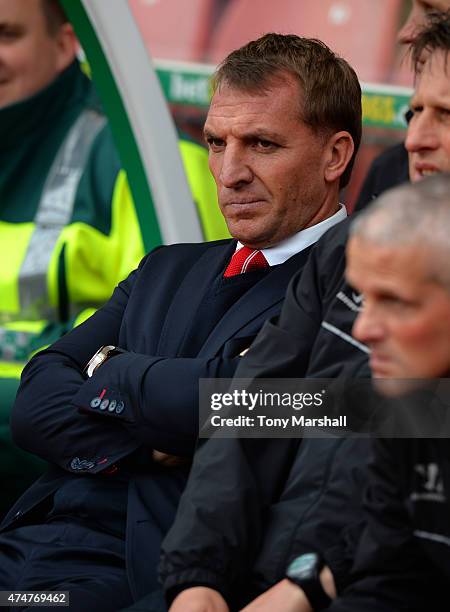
[{"left": 199, "top": 248, "right": 309, "bottom": 357}]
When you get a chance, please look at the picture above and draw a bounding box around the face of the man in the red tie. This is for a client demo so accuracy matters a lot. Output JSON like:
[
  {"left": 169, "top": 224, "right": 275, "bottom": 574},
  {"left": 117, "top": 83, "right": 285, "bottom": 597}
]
[{"left": 204, "top": 74, "right": 337, "bottom": 248}]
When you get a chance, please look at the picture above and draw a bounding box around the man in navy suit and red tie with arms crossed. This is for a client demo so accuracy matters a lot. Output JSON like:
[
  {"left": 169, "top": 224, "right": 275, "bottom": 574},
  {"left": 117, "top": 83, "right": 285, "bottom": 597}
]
[{"left": 0, "top": 34, "right": 361, "bottom": 610}]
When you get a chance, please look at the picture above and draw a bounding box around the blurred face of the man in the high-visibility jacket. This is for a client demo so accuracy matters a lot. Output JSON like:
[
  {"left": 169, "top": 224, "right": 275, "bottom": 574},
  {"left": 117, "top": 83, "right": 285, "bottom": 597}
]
[{"left": 0, "top": 0, "right": 66, "bottom": 108}]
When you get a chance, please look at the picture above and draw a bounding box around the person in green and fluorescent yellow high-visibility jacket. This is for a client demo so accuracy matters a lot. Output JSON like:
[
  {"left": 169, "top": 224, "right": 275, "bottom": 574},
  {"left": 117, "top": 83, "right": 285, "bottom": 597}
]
[{"left": 0, "top": 0, "right": 228, "bottom": 514}]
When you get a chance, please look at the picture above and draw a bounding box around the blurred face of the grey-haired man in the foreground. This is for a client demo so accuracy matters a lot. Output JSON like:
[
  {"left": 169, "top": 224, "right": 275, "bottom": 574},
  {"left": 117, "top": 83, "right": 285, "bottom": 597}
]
[{"left": 346, "top": 237, "right": 450, "bottom": 379}]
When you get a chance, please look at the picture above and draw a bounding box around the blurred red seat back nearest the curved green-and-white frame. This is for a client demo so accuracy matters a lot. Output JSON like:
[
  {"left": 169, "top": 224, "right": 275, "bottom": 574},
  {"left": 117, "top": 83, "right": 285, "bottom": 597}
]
[{"left": 129, "top": 0, "right": 214, "bottom": 61}]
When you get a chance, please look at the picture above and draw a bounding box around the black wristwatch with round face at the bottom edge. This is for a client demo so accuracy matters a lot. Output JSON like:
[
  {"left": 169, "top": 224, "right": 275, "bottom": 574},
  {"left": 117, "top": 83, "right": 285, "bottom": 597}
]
[{"left": 286, "top": 553, "right": 332, "bottom": 612}]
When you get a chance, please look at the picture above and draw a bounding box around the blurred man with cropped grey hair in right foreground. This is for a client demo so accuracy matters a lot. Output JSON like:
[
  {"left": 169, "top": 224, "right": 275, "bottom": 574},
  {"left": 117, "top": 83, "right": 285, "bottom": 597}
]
[{"left": 330, "top": 175, "right": 450, "bottom": 612}]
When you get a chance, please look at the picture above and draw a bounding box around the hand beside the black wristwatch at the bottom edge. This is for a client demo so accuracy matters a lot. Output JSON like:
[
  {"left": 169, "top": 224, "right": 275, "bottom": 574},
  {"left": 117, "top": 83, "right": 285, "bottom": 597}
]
[{"left": 239, "top": 578, "right": 313, "bottom": 612}]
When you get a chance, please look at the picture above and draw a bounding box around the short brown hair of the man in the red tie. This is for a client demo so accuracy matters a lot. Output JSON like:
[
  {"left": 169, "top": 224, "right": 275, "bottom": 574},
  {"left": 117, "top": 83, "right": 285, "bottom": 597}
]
[{"left": 213, "top": 33, "right": 361, "bottom": 187}]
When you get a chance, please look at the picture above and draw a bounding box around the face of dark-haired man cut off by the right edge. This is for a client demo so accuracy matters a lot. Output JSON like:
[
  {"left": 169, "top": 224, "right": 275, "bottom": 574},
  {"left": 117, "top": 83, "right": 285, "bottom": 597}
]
[{"left": 405, "top": 51, "right": 450, "bottom": 182}]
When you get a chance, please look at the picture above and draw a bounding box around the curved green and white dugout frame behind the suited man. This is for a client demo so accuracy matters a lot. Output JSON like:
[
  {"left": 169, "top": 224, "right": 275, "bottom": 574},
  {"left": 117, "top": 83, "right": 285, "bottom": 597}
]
[{"left": 62, "top": 0, "right": 203, "bottom": 250}]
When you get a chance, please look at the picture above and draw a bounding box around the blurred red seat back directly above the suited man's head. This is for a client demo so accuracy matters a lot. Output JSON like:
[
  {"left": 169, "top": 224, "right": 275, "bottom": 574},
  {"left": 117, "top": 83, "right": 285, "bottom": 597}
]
[{"left": 207, "top": 0, "right": 402, "bottom": 81}]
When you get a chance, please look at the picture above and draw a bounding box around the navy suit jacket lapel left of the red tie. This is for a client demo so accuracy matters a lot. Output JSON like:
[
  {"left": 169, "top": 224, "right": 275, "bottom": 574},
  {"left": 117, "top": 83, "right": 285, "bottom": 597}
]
[{"left": 158, "top": 240, "right": 236, "bottom": 355}]
